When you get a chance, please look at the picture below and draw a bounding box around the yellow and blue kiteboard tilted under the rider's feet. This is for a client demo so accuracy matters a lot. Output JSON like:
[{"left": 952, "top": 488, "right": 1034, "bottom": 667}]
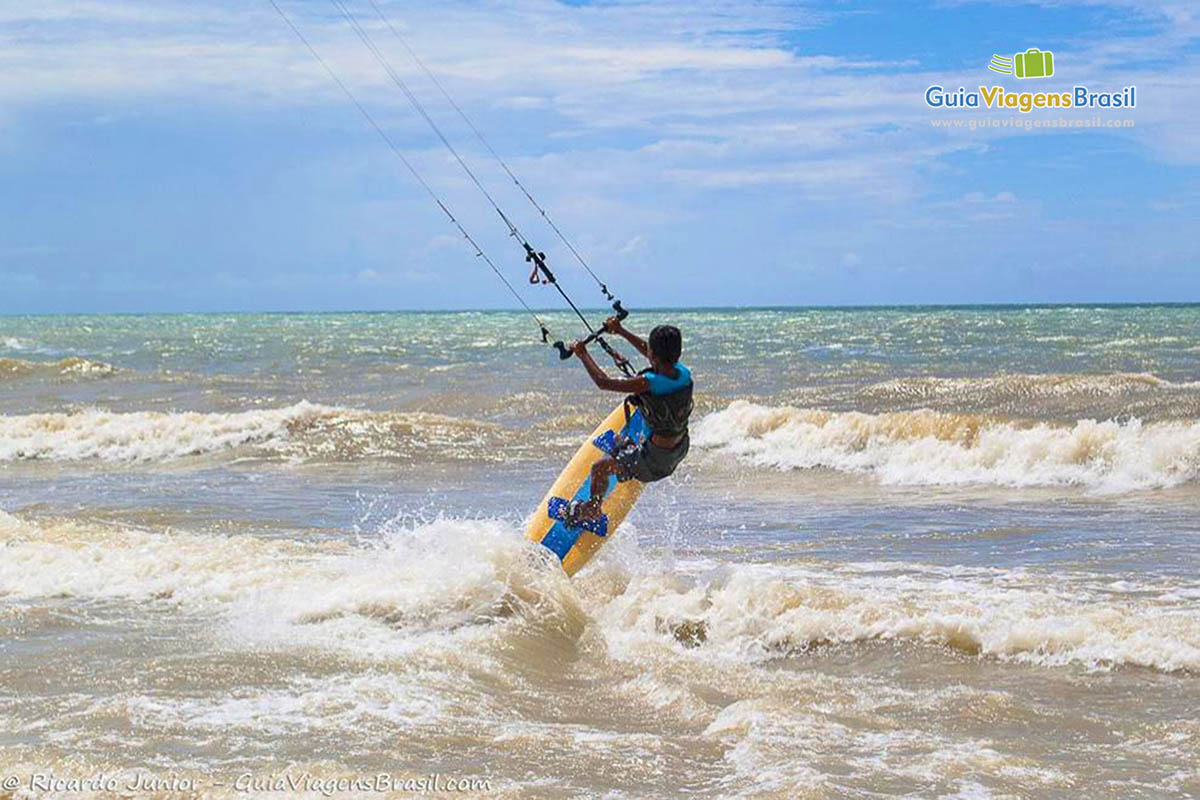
[{"left": 526, "top": 402, "right": 650, "bottom": 576}]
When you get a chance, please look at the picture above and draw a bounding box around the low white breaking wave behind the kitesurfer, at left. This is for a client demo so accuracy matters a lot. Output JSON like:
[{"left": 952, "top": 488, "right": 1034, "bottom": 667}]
[{"left": 0, "top": 402, "right": 518, "bottom": 463}]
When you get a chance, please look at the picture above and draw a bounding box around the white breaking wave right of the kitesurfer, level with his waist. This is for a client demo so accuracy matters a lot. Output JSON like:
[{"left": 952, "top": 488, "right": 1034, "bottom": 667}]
[{"left": 692, "top": 401, "right": 1200, "bottom": 492}]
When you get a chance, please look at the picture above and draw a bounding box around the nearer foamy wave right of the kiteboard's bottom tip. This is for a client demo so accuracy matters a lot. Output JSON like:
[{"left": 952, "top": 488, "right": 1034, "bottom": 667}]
[{"left": 600, "top": 565, "right": 1200, "bottom": 672}]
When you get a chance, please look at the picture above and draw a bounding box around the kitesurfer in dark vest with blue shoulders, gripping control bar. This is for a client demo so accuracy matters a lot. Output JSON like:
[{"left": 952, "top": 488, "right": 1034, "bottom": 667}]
[{"left": 568, "top": 317, "right": 692, "bottom": 523}]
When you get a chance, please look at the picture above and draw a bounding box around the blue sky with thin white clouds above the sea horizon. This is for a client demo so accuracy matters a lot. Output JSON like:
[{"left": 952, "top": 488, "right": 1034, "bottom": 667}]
[{"left": 0, "top": 0, "right": 1200, "bottom": 314}]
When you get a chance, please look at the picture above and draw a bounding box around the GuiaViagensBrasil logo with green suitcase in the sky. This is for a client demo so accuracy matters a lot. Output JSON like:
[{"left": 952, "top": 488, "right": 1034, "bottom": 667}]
[{"left": 925, "top": 47, "right": 1138, "bottom": 114}]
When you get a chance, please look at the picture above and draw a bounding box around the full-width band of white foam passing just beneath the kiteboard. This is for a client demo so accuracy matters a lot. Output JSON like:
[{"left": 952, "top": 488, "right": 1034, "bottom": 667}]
[{"left": 0, "top": 515, "right": 1200, "bottom": 671}]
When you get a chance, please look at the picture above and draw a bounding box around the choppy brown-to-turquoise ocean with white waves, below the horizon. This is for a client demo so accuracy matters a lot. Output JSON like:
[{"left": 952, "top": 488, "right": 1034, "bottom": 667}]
[{"left": 0, "top": 305, "right": 1200, "bottom": 799}]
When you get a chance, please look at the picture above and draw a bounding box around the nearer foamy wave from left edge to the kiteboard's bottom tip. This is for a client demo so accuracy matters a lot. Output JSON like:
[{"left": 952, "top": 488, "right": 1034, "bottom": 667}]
[{"left": 0, "top": 511, "right": 580, "bottom": 658}]
